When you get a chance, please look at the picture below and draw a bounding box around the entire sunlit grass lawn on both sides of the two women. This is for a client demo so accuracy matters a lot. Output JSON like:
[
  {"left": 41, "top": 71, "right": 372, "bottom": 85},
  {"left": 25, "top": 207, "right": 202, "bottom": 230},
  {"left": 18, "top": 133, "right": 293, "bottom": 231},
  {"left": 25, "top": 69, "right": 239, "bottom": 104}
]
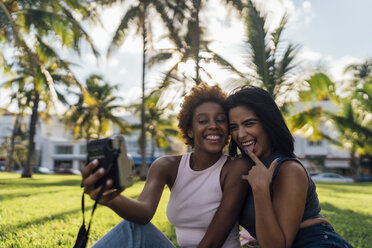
[{"left": 0, "top": 172, "right": 372, "bottom": 248}]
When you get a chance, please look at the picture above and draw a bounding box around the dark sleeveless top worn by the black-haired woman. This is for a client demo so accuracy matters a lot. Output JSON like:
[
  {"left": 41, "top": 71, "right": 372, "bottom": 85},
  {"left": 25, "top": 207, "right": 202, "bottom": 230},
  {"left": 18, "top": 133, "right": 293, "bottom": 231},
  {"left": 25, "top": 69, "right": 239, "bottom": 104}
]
[{"left": 239, "top": 152, "right": 323, "bottom": 238}]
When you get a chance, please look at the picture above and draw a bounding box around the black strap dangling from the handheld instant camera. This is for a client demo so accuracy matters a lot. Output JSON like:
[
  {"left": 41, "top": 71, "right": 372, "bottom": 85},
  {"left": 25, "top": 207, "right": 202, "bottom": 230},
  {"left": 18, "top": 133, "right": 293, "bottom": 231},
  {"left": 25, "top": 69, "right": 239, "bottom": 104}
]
[{"left": 73, "top": 150, "right": 120, "bottom": 248}]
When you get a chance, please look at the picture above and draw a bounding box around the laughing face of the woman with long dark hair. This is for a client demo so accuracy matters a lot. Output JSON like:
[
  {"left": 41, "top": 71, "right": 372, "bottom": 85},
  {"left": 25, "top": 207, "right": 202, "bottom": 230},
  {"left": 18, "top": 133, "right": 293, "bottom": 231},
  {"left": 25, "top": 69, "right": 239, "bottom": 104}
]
[{"left": 229, "top": 106, "right": 271, "bottom": 160}]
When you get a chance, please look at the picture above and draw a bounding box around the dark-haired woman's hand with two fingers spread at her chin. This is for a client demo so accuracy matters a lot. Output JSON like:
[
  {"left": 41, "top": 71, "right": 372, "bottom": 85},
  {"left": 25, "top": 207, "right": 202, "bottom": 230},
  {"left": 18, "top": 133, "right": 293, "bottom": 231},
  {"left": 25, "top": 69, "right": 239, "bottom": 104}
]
[{"left": 241, "top": 149, "right": 281, "bottom": 192}]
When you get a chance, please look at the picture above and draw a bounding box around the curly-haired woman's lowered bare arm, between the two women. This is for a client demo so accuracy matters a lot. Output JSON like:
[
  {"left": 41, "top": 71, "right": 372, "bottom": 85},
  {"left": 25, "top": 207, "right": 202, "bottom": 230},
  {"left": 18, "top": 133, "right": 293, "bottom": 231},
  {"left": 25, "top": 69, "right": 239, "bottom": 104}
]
[{"left": 198, "top": 159, "right": 250, "bottom": 248}]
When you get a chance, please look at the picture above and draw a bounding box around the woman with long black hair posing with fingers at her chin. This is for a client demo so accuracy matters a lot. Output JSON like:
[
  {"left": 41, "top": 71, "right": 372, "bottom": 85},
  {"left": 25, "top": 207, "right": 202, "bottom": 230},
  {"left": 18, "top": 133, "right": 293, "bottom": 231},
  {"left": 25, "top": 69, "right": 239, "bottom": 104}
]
[{"left": 226, "top": 86, "right": 352, "bottom": 248}]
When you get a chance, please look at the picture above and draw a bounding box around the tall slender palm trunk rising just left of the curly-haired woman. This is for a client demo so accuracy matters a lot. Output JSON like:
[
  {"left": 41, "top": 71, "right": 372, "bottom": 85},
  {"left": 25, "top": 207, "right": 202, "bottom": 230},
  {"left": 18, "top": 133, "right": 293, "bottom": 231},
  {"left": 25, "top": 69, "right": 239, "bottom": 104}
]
[{"left": 140, "top": 3, "right": 148, "bottom": 180}]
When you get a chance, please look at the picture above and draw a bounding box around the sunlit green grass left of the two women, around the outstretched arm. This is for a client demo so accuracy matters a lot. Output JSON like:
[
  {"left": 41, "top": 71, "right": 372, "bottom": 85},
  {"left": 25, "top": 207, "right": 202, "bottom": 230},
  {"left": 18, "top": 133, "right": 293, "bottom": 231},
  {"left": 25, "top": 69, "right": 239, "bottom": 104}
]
[{"left": 0, "top": 172, "right": 176, "bottom": 248}]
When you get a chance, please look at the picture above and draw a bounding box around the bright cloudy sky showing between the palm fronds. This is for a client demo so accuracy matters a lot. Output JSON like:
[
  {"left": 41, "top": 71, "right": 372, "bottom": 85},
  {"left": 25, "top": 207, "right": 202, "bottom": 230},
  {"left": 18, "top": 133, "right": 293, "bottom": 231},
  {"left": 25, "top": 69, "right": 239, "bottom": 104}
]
[{"left": 0, "top": 0, "right": 372, "bottom": 112}]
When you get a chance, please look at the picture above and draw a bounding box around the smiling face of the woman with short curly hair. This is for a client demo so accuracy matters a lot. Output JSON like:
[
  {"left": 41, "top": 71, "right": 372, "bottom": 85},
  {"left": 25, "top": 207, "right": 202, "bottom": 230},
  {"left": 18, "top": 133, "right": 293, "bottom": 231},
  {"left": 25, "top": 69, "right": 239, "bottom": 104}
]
[{"left": 187, "top": 102, "right": 228, "bottom": 153}]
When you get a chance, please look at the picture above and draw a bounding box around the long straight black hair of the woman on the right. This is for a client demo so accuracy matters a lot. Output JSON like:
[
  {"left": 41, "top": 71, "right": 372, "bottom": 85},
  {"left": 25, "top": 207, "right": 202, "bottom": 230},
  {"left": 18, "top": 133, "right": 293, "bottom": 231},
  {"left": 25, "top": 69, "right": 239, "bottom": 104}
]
[{"left": 226, "top": 86, "right": 295, "bottom": 157}]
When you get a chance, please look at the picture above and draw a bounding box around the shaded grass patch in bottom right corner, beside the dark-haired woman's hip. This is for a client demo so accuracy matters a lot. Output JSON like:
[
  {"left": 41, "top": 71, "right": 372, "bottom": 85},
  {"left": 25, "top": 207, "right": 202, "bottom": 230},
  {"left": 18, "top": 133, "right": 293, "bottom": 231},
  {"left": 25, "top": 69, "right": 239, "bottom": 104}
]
[{"left": 322, "top": 202, "right": 372, "bottom": 248}]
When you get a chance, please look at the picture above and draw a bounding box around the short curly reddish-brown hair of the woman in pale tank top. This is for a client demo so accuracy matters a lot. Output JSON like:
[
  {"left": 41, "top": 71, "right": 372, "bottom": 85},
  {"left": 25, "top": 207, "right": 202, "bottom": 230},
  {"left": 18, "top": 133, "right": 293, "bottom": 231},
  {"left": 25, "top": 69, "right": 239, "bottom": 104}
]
[{"left": 177, "top": 83, "right": 227, "bottom": 147}]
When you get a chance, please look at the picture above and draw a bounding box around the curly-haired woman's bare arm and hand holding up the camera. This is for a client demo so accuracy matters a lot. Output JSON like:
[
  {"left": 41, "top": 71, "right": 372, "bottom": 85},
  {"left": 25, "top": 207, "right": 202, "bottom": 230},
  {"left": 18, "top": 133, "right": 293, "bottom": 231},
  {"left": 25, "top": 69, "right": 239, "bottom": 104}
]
[{"left": 83, "top": 158, "right": 170, "bottom": 224}]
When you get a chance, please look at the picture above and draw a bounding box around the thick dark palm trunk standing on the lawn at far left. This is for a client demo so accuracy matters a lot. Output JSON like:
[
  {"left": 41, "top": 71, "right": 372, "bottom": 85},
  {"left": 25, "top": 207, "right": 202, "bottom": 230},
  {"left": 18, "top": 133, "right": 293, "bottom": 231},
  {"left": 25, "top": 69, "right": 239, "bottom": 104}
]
[{"left": 22, "top": 89, "right": 40, "bottom": 177}]
